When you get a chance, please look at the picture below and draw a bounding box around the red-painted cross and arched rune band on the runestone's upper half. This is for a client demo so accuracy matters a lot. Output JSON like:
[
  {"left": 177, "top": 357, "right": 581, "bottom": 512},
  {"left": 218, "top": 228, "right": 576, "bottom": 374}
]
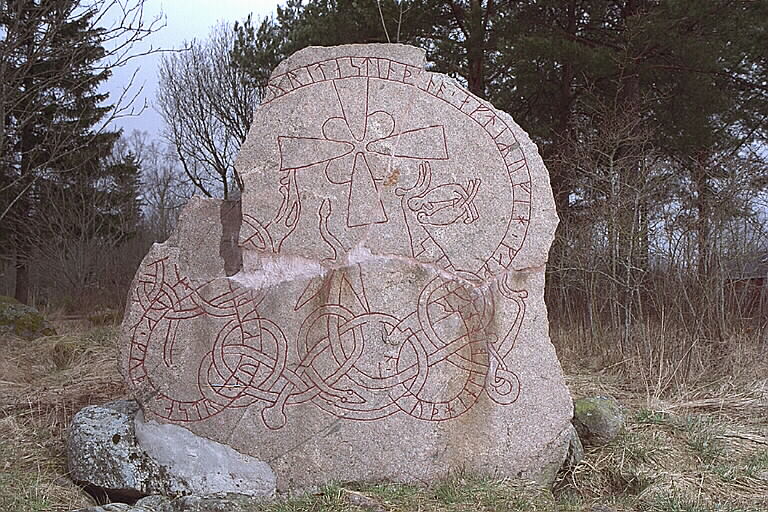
[{"left": 241, "top": 56, "right": 531, "bottom": 278}]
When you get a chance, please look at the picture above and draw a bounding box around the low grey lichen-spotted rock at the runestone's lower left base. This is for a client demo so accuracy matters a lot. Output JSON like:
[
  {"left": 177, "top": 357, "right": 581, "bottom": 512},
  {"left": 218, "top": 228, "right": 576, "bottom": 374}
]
[{"left": 67, "top": 400, "right": 275, "bottom": 500}]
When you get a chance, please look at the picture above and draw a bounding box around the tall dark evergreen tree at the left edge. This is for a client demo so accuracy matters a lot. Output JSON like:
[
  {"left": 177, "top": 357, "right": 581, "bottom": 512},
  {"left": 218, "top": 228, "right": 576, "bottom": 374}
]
[{"left": 0, "top": 0, "right": 138, "bottom": 302}]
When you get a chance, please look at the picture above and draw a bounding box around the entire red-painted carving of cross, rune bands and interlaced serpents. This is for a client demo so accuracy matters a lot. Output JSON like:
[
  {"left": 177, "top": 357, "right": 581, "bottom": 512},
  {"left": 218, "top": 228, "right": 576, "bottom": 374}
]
[{"left": 130, "top": 52, "right": 531, "bottom": 429}]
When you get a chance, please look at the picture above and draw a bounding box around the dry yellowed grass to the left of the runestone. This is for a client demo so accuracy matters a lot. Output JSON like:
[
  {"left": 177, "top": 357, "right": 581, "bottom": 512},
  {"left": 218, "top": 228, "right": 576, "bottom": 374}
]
[{"left": 0, "top": 320, "right": 124, "bottom": 512}]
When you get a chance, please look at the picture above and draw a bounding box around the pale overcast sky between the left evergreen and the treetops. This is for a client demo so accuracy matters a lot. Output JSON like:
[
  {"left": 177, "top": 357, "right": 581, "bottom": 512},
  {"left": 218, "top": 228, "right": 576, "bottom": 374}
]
[{"left": 106, "top": 0, "right": 280, "bottom": 137}]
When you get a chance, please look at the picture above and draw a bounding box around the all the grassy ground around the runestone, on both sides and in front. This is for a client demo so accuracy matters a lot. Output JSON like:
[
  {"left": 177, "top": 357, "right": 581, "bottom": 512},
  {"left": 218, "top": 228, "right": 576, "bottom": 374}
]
[{"left": 0, "top": 320, "right": 768, "bottom": 512}]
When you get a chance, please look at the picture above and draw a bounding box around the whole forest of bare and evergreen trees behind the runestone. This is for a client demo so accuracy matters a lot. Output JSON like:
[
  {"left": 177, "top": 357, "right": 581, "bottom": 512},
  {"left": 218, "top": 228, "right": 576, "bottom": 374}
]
[{"left": 0, "top": 0, "right": 768, "bottom": 387}]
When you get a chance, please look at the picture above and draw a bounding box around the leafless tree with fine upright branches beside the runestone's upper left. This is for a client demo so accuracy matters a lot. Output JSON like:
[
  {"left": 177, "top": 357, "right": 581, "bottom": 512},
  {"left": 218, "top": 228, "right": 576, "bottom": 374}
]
[{"left": 158, "top": 24, "right": 259, "bottom": 199}]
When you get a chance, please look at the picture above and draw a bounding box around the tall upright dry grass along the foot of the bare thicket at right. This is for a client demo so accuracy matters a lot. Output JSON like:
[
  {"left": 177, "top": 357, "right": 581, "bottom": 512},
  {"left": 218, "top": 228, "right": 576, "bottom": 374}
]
[{"left": 551, "top": 325, "right": 768, "bottom": 400}]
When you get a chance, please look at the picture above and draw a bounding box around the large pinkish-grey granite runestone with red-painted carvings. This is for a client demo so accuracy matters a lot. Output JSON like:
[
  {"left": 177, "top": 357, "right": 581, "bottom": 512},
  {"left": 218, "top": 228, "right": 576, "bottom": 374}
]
[{"left": 121, "top": 45, "right": 572, "bottom": 490}]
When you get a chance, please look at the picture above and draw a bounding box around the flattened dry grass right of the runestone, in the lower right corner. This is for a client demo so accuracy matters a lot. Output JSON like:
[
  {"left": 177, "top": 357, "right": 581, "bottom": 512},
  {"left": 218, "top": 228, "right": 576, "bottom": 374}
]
[{"left": 556, "top": 336, "right": 768, "bottom": 512}]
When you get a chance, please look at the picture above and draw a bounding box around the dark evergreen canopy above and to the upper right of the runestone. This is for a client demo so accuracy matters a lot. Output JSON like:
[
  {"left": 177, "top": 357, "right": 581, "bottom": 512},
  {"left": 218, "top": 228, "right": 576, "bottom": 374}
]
[{"left": 234, "top": 0, "right": 768, "bottom": 210}]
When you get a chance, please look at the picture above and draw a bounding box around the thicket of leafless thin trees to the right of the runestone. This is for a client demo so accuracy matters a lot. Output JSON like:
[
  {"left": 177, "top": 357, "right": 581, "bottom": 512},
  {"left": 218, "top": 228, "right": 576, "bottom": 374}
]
[{"left": 547, "top": 95, "right": 768, "bottom": 389}]
